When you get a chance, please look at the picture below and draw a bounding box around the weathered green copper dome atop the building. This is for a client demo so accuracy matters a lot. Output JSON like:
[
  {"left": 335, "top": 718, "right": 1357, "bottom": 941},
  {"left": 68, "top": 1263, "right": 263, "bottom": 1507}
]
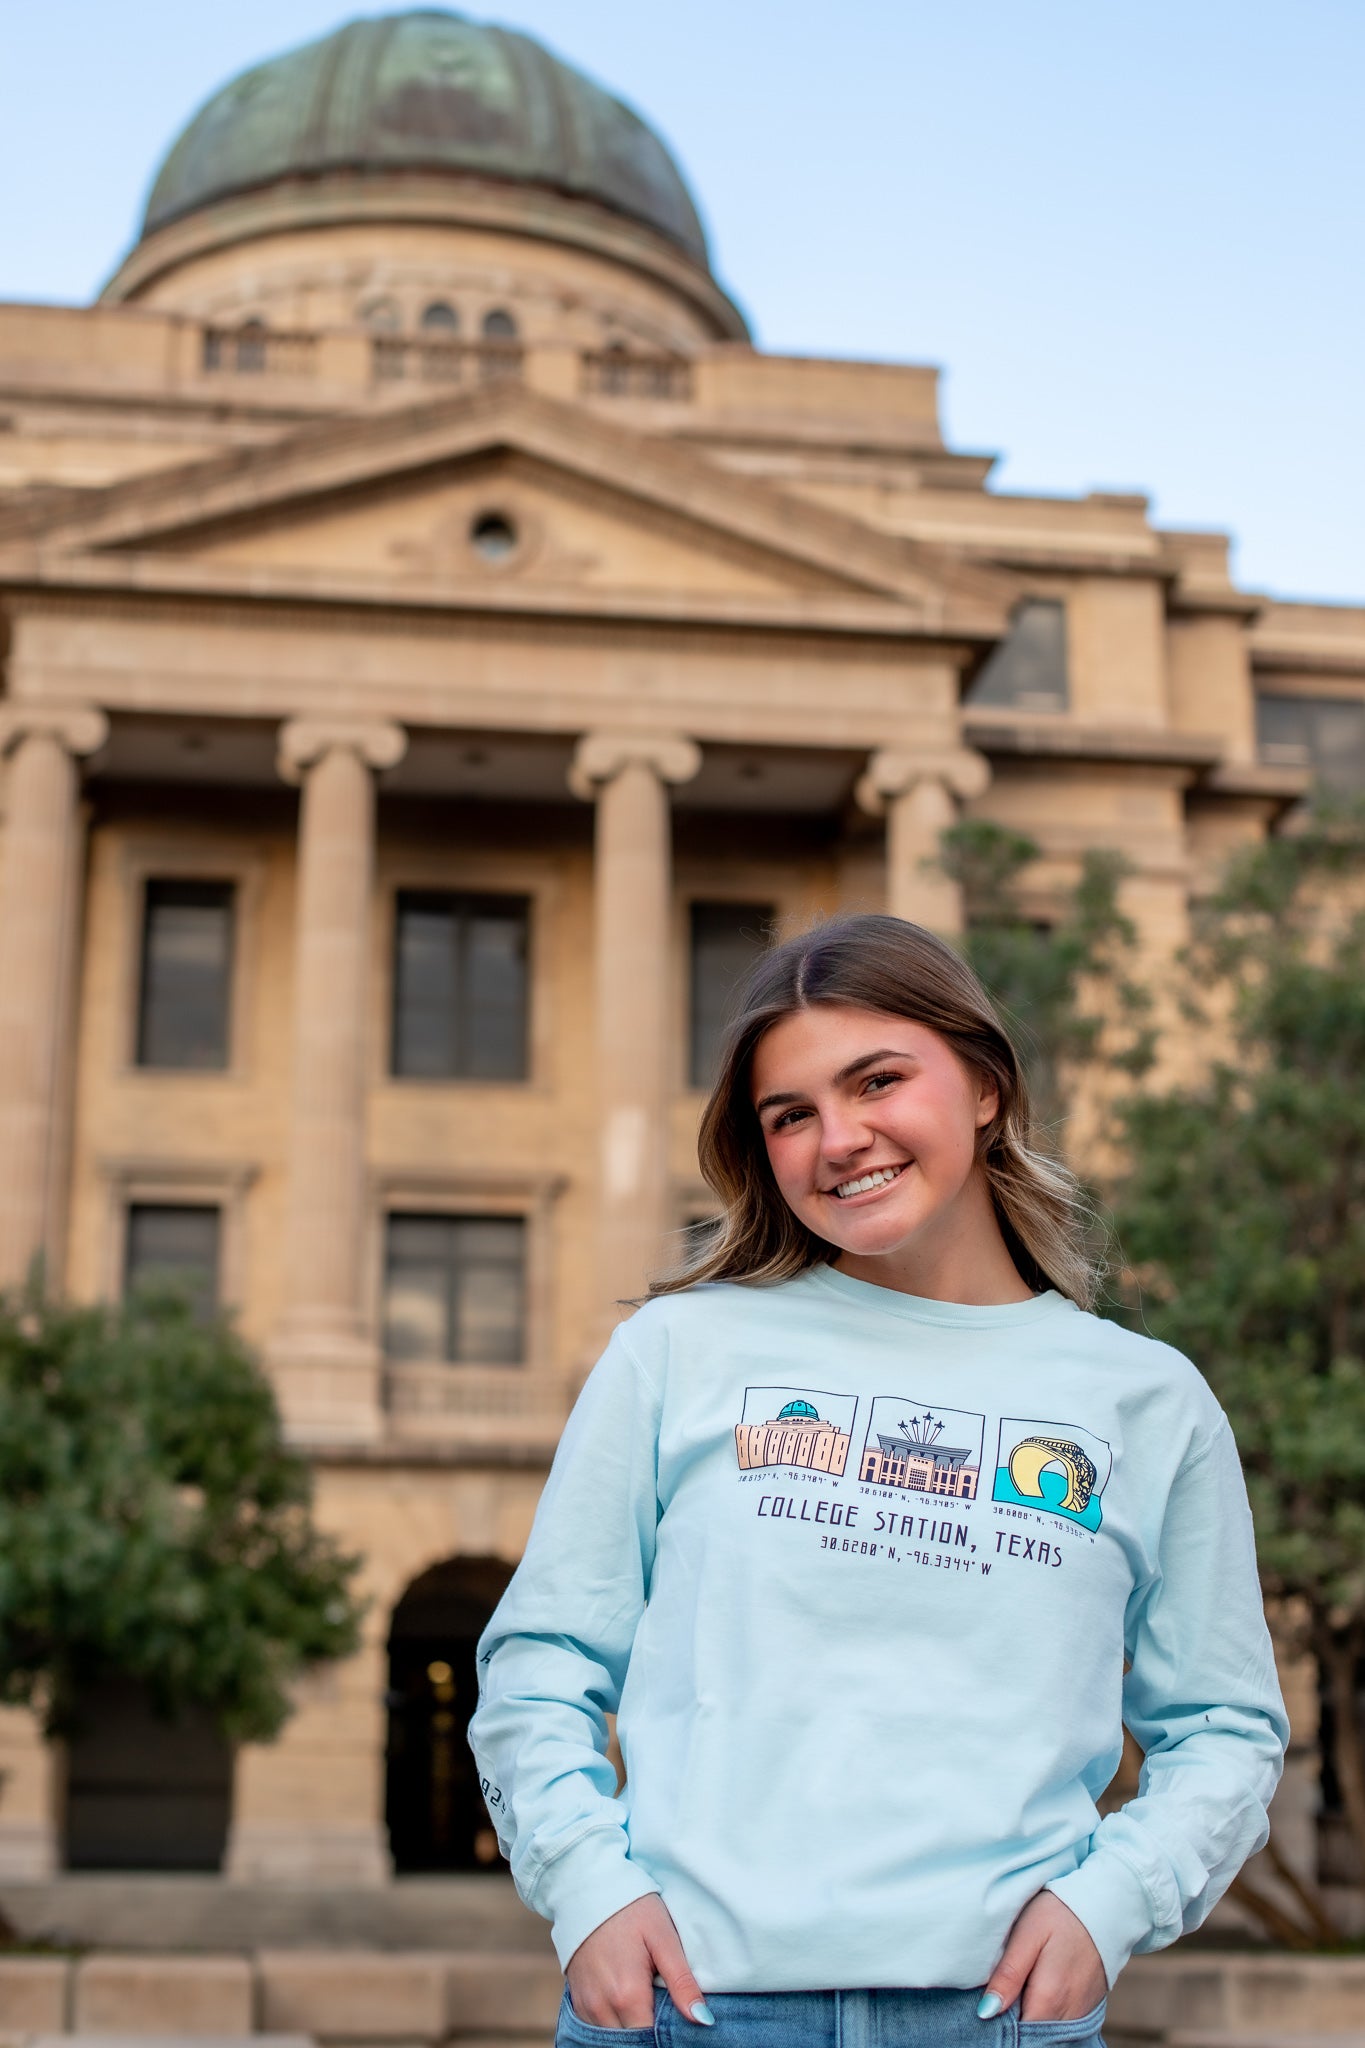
[{"left": 141, "top": 8, "right": 706, "bottom": 266}]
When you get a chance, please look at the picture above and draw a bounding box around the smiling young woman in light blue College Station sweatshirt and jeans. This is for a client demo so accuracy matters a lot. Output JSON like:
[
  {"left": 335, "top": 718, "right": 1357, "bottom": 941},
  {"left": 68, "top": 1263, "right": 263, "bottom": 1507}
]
[{"left": 471, "top": 918, "right": 1287, "bottom": 2048}]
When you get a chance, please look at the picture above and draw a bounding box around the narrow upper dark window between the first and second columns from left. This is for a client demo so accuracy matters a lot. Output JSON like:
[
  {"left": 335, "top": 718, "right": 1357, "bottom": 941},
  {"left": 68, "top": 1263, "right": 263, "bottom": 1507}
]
[{"left": 137, "top": 881, "right": 233, "bottom": 1071}]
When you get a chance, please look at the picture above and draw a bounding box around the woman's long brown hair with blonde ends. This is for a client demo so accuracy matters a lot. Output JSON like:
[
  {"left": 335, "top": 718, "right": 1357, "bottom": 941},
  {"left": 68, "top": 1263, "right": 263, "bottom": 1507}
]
[{"left": 649, "top": 915, "right": 1099, "bottom": 1309}]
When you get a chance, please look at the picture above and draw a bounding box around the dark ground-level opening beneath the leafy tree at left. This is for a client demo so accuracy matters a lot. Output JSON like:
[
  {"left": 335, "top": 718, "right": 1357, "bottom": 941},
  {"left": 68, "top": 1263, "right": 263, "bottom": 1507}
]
[{"left": 65, "top": 1677, "right": 233, "bottom": 1870}]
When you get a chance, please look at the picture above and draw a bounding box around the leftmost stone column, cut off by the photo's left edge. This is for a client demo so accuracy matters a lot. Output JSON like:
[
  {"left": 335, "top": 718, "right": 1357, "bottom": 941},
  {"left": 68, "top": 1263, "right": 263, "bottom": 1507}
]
[{"left": 0, "top": 705, "right": 108, "bottom": 1286}]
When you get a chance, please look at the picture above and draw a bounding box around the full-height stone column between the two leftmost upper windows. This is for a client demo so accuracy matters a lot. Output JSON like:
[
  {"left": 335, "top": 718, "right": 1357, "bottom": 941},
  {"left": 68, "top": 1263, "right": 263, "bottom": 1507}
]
[{"left": 268, "top": 719, "right": 407, "bottom": 1442}]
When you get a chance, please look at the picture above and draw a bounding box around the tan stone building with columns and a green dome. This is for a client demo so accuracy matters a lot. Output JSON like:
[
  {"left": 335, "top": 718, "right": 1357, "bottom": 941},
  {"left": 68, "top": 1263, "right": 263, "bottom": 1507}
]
[{"left": 0, "top": 10, "right": 1365, "bottom": 1884}]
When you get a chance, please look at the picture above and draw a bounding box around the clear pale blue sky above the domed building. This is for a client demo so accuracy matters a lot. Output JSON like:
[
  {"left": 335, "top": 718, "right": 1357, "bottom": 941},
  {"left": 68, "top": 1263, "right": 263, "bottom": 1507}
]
[{"left": 0, "top": 0, "right": 1365, "bottom": 602}]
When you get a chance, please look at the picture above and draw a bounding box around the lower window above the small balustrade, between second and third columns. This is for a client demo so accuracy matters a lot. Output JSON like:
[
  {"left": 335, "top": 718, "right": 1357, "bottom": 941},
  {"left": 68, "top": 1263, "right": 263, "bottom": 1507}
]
[{"left": 385, "top": 1214, "right": 526, "bottom": 1366}]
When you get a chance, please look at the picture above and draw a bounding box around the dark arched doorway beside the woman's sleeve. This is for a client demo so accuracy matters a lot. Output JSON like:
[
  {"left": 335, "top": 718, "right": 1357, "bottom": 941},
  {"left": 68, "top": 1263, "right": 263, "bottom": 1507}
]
[{"left": 387, "top": 1556, "right": 512, "bottom": 1872}]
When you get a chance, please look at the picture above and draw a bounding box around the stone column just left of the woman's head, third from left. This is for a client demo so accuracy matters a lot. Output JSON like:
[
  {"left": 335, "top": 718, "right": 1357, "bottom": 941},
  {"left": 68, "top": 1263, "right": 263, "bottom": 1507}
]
[{"left": 569, "top": 733, "right": 702, "bottom": 1321}]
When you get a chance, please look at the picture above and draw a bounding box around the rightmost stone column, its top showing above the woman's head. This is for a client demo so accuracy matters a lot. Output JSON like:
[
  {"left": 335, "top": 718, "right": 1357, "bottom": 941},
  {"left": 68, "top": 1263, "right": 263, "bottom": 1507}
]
[{"left": 857, "top": 748, "right": 990, "bottom": 938}]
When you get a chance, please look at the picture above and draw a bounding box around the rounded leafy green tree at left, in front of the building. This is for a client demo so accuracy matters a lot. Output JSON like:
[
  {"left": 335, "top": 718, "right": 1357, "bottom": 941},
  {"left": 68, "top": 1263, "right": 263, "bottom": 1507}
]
[{"left": 0, "top": 1278, "right": 360, "bottom": 1741}]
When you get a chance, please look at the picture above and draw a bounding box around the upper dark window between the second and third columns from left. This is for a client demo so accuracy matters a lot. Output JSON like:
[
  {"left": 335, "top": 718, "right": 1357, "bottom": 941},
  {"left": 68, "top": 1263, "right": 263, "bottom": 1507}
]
[{"left": 393, "top": 889, "right": 530, "bottom": 1081}]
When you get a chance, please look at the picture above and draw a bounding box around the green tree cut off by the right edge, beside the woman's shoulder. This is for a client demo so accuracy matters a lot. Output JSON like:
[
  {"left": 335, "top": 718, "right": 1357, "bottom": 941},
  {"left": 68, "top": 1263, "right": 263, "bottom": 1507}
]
[{"left": 1113, "top": 815, "right": 1365, "bottom": 1919}]
